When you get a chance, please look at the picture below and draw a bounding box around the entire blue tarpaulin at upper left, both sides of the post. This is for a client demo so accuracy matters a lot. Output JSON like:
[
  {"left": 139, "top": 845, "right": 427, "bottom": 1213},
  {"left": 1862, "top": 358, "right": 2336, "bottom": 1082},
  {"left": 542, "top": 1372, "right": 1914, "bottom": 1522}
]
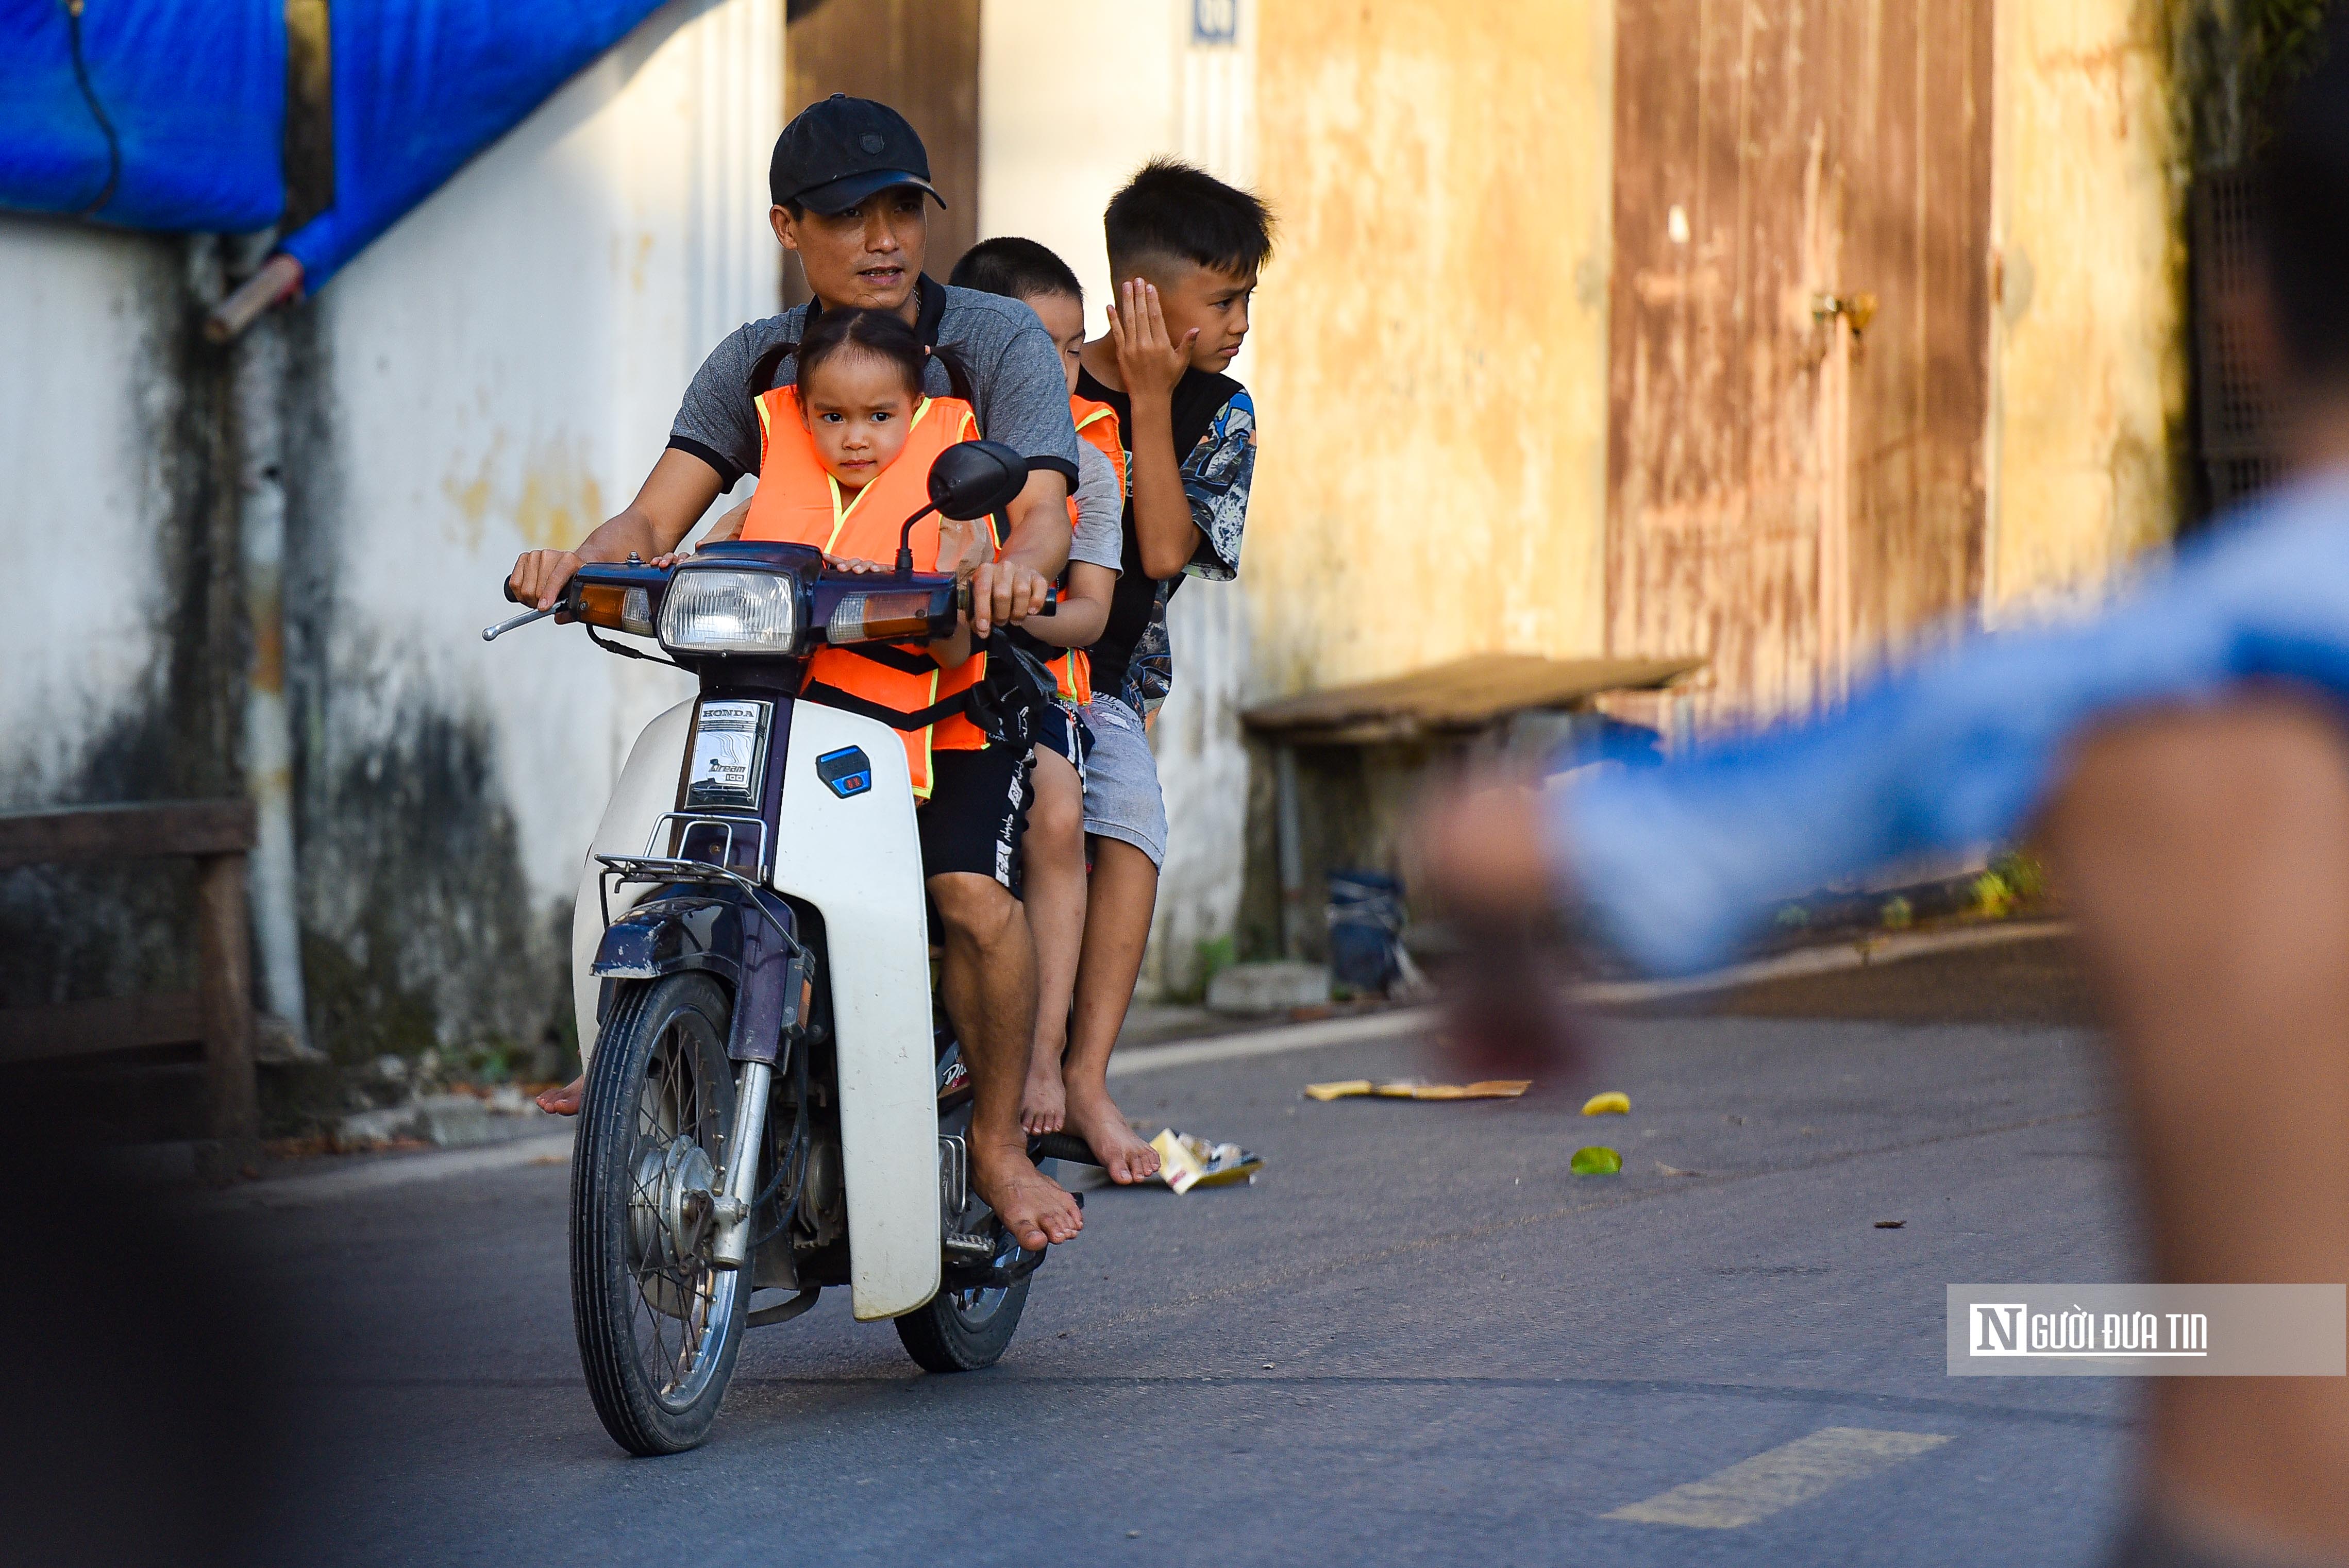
[{"left": 0, "top": 0, "right": 658, "bottom": 289}]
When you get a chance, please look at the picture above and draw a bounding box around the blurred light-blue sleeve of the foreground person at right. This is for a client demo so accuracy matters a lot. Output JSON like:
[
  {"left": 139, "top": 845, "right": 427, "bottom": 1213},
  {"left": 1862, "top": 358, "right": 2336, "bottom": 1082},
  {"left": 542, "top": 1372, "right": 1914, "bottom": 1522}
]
[{"left": 1553, "top": 469, "right": 2349, "bottom": 972}]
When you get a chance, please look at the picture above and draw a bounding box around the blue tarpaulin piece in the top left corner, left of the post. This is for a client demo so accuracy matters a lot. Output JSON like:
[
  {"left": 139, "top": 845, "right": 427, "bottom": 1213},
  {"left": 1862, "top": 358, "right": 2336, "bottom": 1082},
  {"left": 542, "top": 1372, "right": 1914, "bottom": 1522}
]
[{"left": 0, "top": 0, "right": 287, "bottom": 232}]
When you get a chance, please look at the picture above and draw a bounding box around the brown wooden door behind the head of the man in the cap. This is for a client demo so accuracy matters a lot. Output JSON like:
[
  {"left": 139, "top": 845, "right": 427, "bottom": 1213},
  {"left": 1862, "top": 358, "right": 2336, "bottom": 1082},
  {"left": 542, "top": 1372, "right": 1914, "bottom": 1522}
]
[{"left": 782, "top": 0, "right": 980, "bottom": 305}]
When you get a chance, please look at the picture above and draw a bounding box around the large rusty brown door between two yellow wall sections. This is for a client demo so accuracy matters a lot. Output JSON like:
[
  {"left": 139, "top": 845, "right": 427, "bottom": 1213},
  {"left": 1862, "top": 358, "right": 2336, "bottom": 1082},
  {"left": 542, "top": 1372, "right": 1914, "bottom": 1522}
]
[{"left": 1607, "top": 0, "right": 1992, "bottom": 723}]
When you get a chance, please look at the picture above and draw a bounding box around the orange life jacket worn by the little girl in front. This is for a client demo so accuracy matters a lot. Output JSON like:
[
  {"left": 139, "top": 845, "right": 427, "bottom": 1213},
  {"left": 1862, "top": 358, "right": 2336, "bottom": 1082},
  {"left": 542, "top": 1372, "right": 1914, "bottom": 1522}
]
[{"left": 742, "top": 387, "right": 1001, "bottom": 800}]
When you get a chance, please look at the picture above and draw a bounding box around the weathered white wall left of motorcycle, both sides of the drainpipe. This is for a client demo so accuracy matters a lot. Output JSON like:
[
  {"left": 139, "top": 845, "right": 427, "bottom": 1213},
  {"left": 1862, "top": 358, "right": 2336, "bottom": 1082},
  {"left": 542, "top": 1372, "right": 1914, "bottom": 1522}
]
[{"left": 0, "top": 0, "right": 784, "bottom": 1056}]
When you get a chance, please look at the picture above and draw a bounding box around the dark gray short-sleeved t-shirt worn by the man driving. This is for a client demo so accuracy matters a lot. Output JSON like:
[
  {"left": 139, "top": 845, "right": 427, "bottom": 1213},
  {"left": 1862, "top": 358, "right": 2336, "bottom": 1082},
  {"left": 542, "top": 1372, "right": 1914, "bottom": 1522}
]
[{"left": 669, "top": 277, "right": 1078, "bottom": 491}]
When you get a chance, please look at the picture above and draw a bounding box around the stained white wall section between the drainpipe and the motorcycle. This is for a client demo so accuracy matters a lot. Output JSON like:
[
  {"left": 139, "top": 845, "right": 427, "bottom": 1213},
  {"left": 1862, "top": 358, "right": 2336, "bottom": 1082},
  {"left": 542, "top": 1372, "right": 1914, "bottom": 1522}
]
[{"left": 292, "top": 0, "right": 782, "bottom": 1051}]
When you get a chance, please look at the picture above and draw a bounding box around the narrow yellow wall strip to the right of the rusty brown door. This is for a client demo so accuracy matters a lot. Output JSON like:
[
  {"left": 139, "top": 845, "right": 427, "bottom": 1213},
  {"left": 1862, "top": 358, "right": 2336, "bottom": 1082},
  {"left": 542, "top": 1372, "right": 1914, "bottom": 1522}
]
[{"left": 1985, "top": 0, "right": 2187, "bottom": 622}]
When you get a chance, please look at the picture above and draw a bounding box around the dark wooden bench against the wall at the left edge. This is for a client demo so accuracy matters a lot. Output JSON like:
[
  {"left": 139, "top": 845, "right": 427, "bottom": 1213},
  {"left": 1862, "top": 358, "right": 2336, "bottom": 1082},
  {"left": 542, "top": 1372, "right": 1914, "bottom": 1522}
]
[{"left": 0, "top": 800, "right": 261, "bottom": 1176}]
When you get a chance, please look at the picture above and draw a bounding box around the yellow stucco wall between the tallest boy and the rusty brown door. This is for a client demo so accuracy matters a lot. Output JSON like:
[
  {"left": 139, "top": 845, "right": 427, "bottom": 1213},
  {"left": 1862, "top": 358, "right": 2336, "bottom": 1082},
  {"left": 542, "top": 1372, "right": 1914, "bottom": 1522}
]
[{"left": 1245, "top": 0, "right": 1614, "bottom": 697}]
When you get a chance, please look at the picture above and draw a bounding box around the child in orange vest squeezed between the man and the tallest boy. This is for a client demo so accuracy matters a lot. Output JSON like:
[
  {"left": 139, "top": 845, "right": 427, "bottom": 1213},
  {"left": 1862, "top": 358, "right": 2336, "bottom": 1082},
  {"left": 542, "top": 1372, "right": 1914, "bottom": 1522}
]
[{"left": 951, "top": 237, "right": 1158, "bottom": 1178}]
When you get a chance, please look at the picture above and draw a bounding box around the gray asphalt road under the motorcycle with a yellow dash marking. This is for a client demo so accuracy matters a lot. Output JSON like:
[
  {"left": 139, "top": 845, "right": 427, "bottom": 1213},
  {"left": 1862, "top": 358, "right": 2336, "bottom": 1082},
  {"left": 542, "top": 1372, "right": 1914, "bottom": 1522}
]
[{"left": 209, "top": 943, "right": 2133, "bottom": 1568}]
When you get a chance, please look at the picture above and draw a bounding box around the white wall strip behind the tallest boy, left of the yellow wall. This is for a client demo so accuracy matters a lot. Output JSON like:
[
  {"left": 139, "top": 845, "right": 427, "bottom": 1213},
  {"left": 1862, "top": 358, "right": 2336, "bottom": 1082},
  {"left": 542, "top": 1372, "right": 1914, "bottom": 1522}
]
[{"left": 980, "top": 0, "right": 1254, "bottom": 990}]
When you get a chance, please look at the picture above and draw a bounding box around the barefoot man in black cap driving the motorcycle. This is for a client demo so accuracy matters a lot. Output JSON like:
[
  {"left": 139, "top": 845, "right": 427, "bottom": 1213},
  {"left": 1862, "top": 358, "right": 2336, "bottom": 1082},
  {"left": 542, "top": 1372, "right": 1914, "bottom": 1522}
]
[{"left": 508, "top": 94, "right": 1083, "bottom": 1249}]
